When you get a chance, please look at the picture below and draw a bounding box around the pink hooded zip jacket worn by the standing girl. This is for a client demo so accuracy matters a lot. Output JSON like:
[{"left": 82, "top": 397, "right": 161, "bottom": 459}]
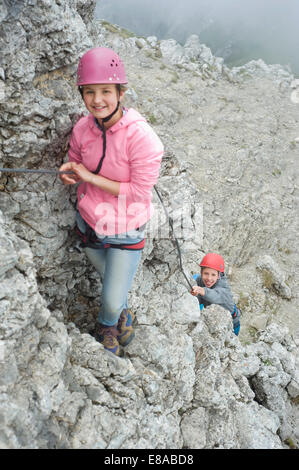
[{"left": 69, "top": 108, "right": 163, "bottom": 235}]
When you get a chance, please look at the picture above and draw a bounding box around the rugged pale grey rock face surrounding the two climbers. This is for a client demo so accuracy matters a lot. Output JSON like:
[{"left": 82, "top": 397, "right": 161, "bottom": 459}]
[{"left": 0, "top": 0, "right": 299, "bottom": 449}]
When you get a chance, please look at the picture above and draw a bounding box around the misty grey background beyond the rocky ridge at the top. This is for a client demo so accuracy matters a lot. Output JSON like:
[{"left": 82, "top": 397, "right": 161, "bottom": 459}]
[{"left": 95, "top": 0, "right": 299, "bottom": 77}]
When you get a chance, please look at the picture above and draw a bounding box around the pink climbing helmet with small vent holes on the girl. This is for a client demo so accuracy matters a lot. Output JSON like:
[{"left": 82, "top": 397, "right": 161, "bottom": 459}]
[{"left": 77, "top": 47, "right": 128, "bottom": 86}]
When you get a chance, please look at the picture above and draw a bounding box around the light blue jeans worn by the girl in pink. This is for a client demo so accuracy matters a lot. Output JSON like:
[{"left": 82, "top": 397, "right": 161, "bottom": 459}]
[{"left": 76, "top": 212, "right": 143, "bottom": 326}]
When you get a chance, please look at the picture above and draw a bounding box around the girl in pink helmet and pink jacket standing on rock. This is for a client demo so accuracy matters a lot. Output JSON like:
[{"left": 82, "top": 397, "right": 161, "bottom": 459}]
[{"left": 60, "top": 47, "right": 163, "bottom": 355}]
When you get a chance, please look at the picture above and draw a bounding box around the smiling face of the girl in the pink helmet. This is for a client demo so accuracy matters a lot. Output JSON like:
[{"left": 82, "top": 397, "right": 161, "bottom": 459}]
[{"left": 83, "top": 84, "right": 124, "bottom": 123}]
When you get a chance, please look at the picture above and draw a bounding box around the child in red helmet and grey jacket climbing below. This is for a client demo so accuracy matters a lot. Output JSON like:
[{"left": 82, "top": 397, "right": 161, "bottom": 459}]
[{"left": 191, "top": 253, "right": 240, "bottom": 335}]
